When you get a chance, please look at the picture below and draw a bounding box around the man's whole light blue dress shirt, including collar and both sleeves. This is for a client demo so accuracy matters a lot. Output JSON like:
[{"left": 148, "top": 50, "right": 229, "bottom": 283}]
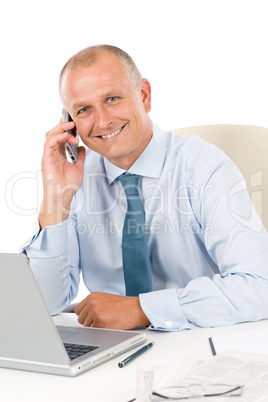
[{"left": 23, "top": 125, "right": 268, "bottom": 331}]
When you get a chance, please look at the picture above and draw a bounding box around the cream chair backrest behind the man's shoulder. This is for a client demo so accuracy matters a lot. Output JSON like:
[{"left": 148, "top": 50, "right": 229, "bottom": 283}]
[{"left": 173, "top": 124, "right": 268, "bottom": 230}]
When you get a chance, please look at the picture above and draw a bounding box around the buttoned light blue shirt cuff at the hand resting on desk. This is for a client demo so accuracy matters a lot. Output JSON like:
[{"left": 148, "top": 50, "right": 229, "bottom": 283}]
[{"left": 139, "top": 289, "right": 195, "bottom": 332}]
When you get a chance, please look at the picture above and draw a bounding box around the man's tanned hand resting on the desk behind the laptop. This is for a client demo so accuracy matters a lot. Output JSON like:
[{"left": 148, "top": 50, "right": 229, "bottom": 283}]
[{"left": 74, "top": 292, "right": 150, "bottom": 329}]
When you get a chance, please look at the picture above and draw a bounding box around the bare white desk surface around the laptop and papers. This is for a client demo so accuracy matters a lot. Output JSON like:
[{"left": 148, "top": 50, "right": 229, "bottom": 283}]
[{"left": 0, "top": 314, "right": 268, "bottom": 402}]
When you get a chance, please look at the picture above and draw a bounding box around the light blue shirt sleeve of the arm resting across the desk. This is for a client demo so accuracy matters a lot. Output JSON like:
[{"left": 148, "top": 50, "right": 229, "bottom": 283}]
[{"left": 140, "top": 163, "right": 268, "bottom": 331}]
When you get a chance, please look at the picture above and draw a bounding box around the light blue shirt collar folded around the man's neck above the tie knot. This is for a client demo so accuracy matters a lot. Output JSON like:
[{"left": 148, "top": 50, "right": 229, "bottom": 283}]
[{"left": 103, "top": 123, "right": 167, "bottom": 184}]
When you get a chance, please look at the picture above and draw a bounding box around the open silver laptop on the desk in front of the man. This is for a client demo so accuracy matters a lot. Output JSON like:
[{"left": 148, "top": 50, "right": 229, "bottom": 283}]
[{"left": 0, "top": 254, "right": 146, "bottom": 376}]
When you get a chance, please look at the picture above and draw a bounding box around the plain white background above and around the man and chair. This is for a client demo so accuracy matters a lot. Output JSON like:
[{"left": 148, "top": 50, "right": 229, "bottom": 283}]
[{"left": 0, "top": 0, "right": 268, "bottom": 252}]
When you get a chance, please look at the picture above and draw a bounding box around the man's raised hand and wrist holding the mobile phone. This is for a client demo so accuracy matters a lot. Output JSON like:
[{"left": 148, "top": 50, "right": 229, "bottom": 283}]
[{"left": 39, "top": 121, "right": 85, "bottom": 228}]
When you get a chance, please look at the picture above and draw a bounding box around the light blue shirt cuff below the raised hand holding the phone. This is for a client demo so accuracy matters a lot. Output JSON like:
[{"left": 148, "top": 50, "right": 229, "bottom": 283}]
[{"left": 20, "top": 220, "right": 68, "bottom": 258}]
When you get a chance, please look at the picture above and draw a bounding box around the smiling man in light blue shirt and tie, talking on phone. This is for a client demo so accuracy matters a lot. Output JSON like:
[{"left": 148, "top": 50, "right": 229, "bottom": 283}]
[{"left": 23, "top": 45, "right": 268, "bottom": 331}]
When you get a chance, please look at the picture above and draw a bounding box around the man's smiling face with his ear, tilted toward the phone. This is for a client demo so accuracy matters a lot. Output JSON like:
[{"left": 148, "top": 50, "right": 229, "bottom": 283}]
[{"left": 61, "top": 54, "right": 152, "bottom": 169}]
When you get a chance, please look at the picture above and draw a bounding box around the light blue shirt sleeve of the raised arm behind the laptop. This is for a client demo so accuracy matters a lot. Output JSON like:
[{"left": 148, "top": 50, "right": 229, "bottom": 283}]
[{"left": 21, "top": 217, "right": 80, "bottom": 315}]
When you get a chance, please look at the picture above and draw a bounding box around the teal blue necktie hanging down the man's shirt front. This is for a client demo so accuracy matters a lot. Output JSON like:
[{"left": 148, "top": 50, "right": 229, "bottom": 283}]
[{"left": 118, "top": 174, "right": 152, "bottom": 296}]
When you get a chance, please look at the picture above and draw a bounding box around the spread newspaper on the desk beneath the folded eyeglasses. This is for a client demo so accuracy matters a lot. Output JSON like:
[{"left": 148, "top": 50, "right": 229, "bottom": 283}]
[{"left": 136, "top": 351, "right": 268, "bottom": 402}]
